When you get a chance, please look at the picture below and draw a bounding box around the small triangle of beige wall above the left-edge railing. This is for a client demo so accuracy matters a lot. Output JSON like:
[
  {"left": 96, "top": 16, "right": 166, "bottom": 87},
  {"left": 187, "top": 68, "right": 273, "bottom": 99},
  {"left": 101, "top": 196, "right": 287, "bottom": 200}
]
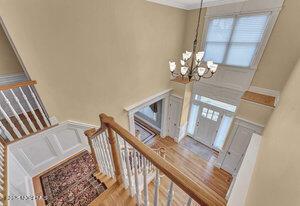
[{"left": 0, "top": 25, "right": 23, "bottom": 75}]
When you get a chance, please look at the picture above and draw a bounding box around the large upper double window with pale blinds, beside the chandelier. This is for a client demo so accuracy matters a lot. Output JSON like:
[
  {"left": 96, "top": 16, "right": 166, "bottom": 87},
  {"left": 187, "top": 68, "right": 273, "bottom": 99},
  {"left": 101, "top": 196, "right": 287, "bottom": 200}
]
[{"left": 204, "top": 13, "right": 269, "bottom": 67}]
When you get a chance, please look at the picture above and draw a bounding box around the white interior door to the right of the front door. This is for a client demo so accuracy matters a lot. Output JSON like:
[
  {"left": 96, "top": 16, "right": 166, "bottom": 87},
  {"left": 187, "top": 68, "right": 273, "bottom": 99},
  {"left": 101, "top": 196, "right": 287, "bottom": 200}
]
[{"left": 221, "top": 126, "right": 254, "bottom": 174}]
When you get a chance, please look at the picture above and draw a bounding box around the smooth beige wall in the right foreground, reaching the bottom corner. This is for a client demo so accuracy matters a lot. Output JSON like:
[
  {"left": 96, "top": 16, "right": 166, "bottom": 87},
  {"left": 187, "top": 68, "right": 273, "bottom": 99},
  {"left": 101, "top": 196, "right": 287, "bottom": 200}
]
[{"left": 246, "top": 59, "right": 300, "bottom": 206}]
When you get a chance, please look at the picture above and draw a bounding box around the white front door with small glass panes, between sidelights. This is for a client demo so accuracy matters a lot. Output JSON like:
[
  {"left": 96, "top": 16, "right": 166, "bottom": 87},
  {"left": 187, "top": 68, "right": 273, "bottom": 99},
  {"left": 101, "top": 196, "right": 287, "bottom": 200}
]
[{"left": 194, "top": 103, "right": 223, "bottom": 148}]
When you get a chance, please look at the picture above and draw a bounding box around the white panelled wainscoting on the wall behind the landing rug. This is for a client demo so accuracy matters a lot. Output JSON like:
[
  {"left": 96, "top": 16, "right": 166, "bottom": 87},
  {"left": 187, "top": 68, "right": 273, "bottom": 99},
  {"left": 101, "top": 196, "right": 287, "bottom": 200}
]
[{"left": 8, "top": 121, "right": 92, "bottom": 177}]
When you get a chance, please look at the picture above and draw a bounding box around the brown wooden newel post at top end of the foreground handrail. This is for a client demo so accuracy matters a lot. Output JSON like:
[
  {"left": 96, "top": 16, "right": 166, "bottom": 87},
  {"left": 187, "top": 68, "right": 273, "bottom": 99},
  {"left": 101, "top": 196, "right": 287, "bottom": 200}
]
[{"left": 100, "top": 114, "right": 123, "bottom": 184}]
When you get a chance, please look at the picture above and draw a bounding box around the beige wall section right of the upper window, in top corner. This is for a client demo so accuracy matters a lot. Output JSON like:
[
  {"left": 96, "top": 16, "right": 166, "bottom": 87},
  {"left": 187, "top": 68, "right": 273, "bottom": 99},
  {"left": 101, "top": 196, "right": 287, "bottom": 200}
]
[{"left": 252, "top": 0, "right": 300, "bottom": 91}]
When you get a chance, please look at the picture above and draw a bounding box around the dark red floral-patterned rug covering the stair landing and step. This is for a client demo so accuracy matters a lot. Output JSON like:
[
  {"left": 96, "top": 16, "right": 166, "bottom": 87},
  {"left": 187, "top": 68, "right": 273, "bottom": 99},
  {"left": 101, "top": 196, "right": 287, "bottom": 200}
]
[{"left": 41, "top": 151, "right": 106, "bottom": 206}]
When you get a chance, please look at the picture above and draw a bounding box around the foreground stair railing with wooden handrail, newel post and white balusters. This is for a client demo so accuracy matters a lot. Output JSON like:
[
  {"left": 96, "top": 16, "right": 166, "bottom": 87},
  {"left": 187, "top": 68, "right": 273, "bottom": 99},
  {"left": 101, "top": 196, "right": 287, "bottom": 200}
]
[{"left": 85, "top": 114, "right": 226, "bottom": 206}]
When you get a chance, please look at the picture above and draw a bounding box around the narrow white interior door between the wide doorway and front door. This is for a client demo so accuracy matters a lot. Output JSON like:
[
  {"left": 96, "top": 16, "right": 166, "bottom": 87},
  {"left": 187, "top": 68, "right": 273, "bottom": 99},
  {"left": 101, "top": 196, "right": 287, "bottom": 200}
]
[{"left": 168, "top": 96, "right": 182, "bottom": 138}]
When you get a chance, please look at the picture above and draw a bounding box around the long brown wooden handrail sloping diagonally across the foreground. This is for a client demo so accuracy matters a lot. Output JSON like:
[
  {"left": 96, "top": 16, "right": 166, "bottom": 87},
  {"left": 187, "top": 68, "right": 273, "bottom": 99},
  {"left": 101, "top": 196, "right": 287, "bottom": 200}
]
[{"left": 100, "top": 114, "right": 226, "bottom": 206}]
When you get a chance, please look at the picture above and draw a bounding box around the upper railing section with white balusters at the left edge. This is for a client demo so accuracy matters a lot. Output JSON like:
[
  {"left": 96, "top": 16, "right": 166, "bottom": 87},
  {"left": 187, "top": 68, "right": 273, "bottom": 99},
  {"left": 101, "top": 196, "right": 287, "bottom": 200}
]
[{"left": 0, "top": 81, "right": 51, "bottom": 143}]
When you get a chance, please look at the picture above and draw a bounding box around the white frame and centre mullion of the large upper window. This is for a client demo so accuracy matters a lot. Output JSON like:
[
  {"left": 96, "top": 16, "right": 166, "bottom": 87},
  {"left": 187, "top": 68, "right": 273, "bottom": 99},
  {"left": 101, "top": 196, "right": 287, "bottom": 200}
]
[{"left": 200, "top": 10, "right": 277, "bottom": 70}]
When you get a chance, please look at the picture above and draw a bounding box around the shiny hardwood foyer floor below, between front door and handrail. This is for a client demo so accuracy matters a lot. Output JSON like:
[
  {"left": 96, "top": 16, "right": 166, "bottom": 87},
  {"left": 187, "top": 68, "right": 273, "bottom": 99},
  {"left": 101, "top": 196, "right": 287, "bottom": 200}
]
[{"left": 149, "top": 136, "right": 232, "bottom": 198}]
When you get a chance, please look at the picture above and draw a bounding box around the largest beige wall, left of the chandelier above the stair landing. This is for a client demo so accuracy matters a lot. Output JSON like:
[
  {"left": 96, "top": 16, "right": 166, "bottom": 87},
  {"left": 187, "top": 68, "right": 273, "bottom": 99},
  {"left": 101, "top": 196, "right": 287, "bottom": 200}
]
[{"left": 0, "top": 0, "right": 186, "bottom": 126}]
